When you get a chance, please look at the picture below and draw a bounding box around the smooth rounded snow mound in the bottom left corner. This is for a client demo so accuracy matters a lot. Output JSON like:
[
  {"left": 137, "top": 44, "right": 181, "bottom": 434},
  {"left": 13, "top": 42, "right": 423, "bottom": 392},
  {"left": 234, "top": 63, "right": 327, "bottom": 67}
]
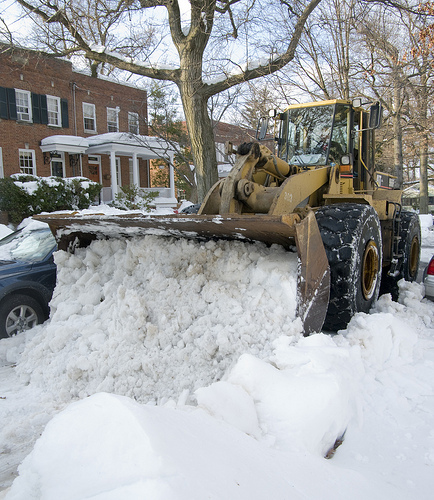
[{"left": 7, "top": 394, "right": 162, "bottom": 500}]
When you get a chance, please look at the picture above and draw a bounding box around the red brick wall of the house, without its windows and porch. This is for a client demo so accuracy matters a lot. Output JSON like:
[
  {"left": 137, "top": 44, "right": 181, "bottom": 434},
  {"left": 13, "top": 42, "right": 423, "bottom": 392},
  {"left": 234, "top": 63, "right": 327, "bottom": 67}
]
[{"left": 0, "top": 45, "right": 149, "bottom": 187}]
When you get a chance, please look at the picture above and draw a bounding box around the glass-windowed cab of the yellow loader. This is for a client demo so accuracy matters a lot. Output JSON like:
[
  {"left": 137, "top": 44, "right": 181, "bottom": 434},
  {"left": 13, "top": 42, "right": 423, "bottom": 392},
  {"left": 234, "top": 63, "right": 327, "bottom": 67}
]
[{"left": 277, "top": 100, "right": 381, "bottom": 192}]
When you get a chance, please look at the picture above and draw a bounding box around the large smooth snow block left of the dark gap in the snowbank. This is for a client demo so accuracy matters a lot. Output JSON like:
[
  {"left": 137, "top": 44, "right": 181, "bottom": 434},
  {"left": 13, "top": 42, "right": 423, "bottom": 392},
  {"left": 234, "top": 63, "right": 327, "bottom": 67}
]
[{"left": 222, "top": 335, "right": 358, "bottom": 456}]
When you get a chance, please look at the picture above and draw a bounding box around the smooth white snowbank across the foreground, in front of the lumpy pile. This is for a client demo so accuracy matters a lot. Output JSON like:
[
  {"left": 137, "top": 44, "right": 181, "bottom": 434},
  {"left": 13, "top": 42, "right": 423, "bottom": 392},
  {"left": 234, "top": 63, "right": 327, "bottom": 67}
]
[{"left": 6, "top": 283, "right": 434, "bottom": 500}]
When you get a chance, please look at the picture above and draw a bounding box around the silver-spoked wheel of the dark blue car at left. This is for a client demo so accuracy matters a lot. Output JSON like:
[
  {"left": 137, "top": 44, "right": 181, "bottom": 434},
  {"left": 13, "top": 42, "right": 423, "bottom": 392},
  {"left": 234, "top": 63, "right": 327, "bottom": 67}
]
[{"left": 0, "top": 295, "right": 45, "bottom": 338}]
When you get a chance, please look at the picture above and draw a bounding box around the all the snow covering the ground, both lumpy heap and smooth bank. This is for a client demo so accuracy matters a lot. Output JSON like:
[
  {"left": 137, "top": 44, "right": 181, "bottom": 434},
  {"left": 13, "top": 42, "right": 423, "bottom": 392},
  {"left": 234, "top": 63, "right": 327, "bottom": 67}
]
[{"left": 0, "top": 209, "right": 434, "bottom": 500}]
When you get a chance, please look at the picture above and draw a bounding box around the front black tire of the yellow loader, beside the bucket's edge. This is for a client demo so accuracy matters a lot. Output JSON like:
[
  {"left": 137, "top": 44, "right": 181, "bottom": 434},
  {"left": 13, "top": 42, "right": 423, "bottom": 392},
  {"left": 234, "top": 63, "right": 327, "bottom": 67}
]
[{"left": 316, "top": 203, "right": 382, "bottom": 332}]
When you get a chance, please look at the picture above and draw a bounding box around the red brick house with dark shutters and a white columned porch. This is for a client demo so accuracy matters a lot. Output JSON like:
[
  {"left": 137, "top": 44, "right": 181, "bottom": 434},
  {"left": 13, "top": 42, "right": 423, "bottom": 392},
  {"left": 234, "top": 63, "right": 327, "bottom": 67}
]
[{"left": 0, "top": 44, "right": 174, "bottom": 205}]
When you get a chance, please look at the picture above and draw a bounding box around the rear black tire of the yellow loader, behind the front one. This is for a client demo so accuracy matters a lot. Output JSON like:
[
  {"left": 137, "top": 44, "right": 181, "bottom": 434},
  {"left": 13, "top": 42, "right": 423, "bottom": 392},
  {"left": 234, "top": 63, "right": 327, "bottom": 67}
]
[{"left": 380, "top": 211, "right": 422, "bottom": 300}]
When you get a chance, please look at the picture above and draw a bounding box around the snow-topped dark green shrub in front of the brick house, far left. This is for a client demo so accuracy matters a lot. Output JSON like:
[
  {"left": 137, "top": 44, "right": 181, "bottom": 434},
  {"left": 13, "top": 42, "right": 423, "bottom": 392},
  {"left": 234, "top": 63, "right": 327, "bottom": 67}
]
[{"left": 0, "top": 174, "right": 102, "bottom": 224}]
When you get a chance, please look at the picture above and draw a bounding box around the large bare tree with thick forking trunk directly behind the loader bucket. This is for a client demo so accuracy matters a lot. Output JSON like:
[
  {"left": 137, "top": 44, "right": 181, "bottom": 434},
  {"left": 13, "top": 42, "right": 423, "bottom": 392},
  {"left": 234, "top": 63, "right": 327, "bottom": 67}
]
[{"left": 14, "top": 0, "right": 321, "bottom": 199}]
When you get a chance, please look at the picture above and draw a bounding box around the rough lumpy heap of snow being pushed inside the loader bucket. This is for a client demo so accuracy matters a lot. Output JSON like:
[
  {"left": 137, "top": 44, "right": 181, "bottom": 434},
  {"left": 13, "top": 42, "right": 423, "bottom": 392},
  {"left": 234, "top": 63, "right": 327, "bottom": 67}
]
[{"left": 17, "top": 236, "right": 302, "bottom": 403}]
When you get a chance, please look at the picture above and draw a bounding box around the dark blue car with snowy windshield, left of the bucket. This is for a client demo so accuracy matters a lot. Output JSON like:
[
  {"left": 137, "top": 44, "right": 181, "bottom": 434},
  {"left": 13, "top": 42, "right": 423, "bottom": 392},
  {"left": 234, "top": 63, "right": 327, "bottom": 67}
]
[{"left": 0, "top": 223, "right": 57, "bottom": 338}]
